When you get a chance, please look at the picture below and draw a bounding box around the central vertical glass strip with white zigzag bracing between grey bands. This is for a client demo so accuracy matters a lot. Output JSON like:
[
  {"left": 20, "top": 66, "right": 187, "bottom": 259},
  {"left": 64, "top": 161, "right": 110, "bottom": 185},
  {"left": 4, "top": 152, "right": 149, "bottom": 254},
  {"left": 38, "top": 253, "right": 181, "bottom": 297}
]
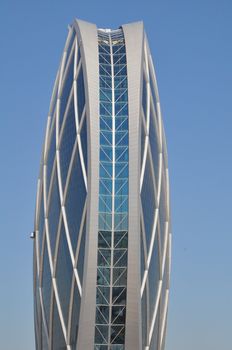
[{"left": 95, "top": 29, "right": 129, "bottom": 350}]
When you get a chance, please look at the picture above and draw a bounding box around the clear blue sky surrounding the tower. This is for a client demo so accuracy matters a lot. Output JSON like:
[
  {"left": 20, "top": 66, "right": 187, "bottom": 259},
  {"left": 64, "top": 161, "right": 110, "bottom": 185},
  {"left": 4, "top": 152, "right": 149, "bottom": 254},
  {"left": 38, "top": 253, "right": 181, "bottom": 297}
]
[{"left": 0, "top": 0, "right": 232, "bottom": 350}]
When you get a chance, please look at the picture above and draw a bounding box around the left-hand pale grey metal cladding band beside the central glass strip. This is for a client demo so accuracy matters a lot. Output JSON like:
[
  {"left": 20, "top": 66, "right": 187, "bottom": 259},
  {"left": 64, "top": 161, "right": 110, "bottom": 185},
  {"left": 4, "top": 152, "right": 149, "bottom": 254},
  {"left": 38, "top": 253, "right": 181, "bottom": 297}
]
[{"left": 75, "top": 21, "right": 99, "bottom": 350}]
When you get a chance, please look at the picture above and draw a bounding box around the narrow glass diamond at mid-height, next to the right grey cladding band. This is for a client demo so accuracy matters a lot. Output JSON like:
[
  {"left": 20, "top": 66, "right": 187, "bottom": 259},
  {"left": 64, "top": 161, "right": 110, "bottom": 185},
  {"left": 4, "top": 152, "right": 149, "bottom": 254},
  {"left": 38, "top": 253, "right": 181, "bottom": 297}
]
[{"left": 141, "top": 155, "right": 156, "bottom": 247}]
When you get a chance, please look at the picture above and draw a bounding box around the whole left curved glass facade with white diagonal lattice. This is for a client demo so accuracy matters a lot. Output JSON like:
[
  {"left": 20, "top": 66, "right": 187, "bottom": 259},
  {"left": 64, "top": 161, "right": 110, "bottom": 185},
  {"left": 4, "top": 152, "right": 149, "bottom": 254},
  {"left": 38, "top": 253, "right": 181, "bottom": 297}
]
[{"left": 34, "top": 28, "right": 88, "bottom": 350}]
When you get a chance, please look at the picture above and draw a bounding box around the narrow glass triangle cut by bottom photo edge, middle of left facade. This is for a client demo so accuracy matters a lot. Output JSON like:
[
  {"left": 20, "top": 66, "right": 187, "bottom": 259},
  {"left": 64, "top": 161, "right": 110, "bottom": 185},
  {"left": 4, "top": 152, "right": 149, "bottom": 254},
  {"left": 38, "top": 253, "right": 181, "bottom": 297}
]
[{"left": 52, "top": 299, "right": 66, "bottom": 350}]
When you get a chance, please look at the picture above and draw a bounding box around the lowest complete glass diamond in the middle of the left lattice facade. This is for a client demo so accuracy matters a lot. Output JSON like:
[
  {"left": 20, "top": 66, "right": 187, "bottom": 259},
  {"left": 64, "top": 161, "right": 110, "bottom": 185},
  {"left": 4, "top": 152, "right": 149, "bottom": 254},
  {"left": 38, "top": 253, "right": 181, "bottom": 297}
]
[{"left": 56, "top": 222, "right": 73, "bottom": 327}]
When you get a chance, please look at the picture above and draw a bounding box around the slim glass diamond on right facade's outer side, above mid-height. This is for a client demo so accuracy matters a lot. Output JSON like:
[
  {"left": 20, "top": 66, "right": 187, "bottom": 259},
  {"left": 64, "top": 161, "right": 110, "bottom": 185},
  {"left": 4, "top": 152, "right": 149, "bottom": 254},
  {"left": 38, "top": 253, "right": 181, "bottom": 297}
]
[{"left": 149, "top": 113, "right": 160, "bottom": 187}]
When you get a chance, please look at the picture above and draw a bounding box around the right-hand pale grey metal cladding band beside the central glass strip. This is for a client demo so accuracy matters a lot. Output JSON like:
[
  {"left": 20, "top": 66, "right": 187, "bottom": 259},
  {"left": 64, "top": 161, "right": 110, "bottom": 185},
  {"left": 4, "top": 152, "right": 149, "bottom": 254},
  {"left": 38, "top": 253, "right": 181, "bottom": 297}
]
[{"left": 123, "top": 22, "right": 143, "bottom": 350}]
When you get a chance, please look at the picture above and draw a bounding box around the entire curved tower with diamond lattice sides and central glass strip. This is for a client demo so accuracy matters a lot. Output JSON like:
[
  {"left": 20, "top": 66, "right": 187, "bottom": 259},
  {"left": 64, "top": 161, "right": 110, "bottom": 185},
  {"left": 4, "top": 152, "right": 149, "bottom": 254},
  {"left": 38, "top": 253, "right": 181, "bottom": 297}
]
[{"left": 34, "top": 20, "right": 171, "bottom": 350}]
